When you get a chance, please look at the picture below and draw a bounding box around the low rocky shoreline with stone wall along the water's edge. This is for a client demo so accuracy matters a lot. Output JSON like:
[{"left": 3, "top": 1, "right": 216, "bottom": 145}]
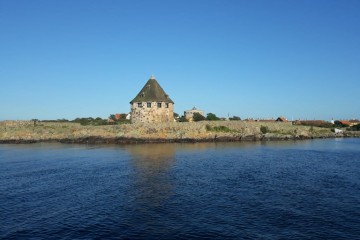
[{"left": 0, "top": 121, "right": 360, "bottom": 144}]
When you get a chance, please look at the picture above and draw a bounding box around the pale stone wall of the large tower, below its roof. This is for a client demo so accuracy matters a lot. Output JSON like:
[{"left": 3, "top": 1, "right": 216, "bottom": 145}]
[{"left": 131, "top": 102, "right": 174, "bottom": 123}]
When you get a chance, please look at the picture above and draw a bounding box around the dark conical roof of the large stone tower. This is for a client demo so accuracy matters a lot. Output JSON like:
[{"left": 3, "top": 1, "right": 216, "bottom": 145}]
[{"left": 130, "top": 76, "right": 174, "bottom": 104}]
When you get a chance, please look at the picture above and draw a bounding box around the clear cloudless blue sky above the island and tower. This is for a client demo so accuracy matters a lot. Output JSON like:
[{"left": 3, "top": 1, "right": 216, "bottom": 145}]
[{"left": 0, "top": 0, "right": 360, "bottom": 120}]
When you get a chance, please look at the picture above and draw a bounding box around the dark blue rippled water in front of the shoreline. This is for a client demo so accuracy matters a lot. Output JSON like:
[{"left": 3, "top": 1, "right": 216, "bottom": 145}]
[{"left": 0, "top": 139, "right": 360, "bottom": 239}]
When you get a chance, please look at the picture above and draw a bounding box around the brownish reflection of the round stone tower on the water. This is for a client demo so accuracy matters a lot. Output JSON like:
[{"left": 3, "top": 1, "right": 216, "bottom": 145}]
[{"left": 126, "top": 144, "right": 176, "bottom": 209}]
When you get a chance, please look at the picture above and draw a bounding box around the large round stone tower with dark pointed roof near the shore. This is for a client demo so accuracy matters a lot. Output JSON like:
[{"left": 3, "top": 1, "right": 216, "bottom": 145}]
[{"left": 130, "top": 76, "right": 174, "bottom": 123}]
